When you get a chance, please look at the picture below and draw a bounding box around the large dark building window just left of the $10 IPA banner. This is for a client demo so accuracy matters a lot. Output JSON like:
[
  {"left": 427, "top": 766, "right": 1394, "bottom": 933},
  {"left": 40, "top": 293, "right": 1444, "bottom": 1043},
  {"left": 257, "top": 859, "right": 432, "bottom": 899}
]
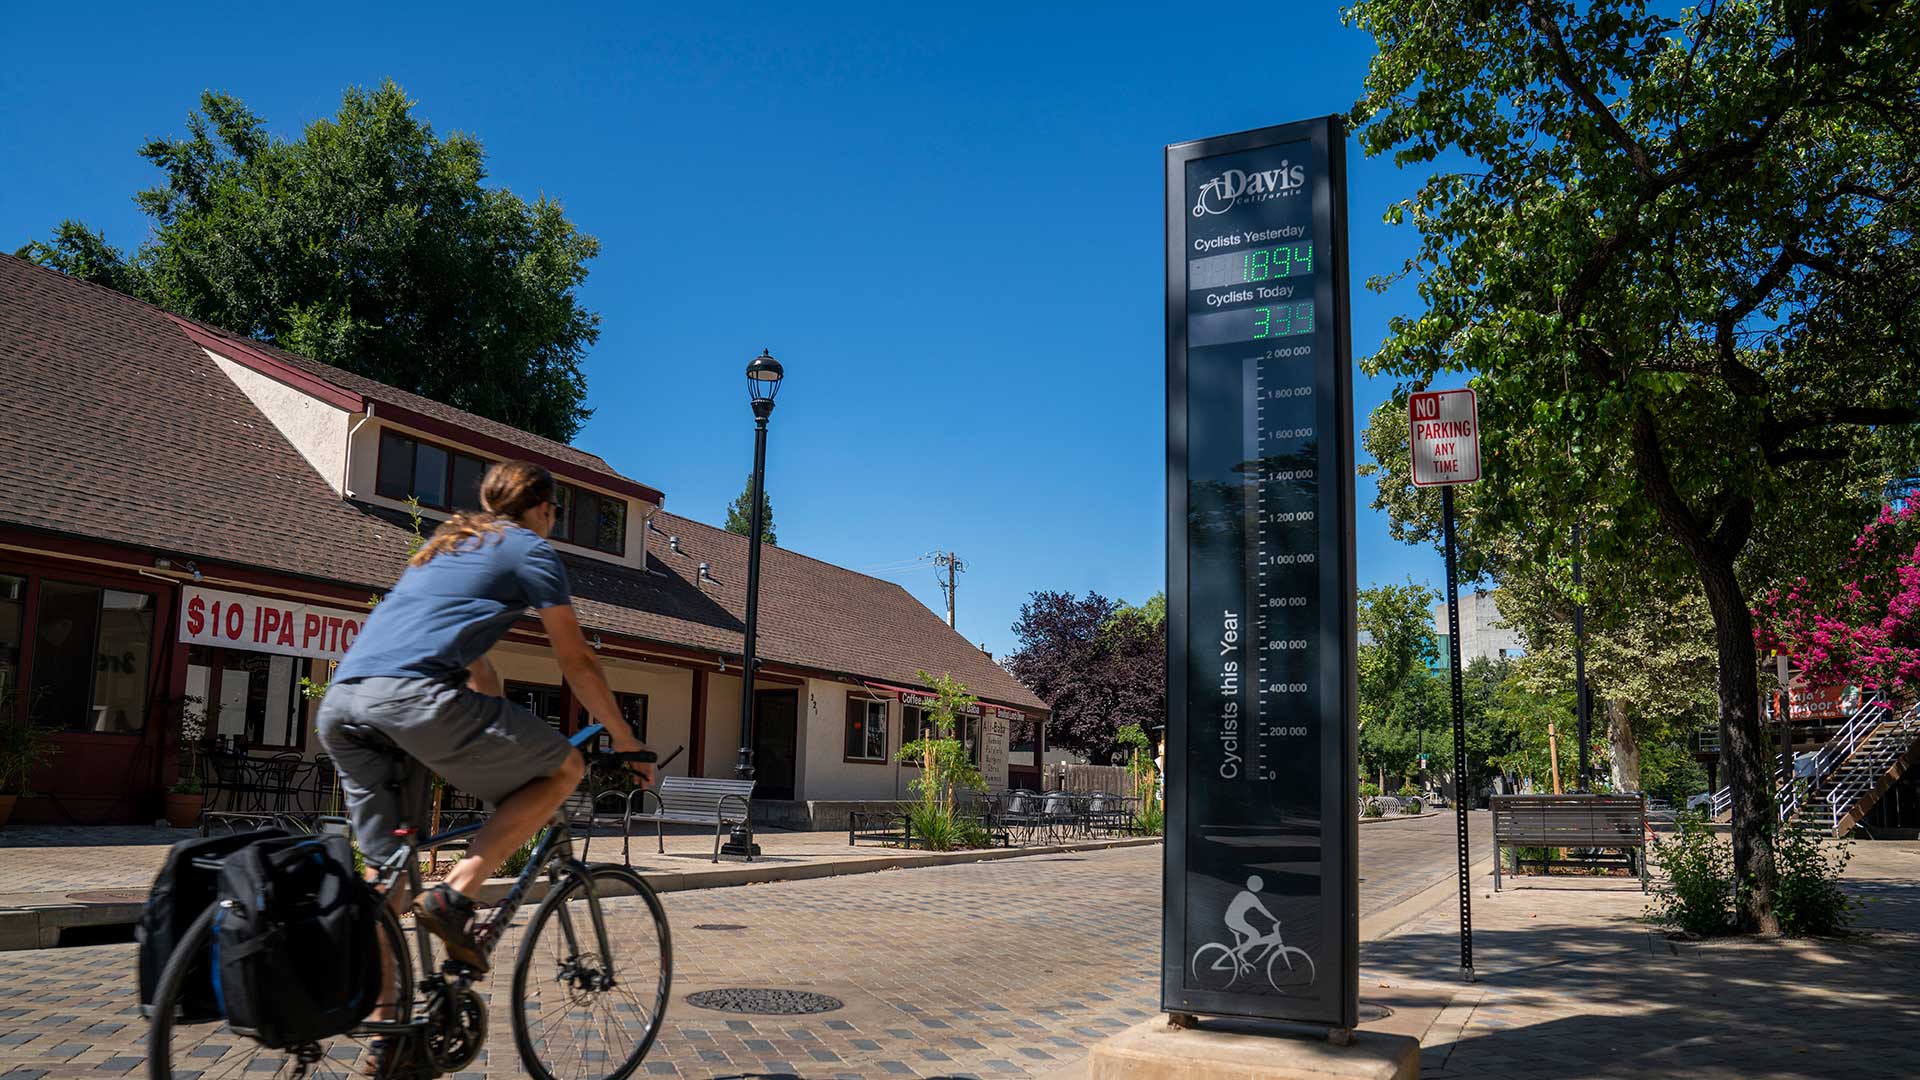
[{"left": 27, "top": 578, "right": 154, "bottom": 734}]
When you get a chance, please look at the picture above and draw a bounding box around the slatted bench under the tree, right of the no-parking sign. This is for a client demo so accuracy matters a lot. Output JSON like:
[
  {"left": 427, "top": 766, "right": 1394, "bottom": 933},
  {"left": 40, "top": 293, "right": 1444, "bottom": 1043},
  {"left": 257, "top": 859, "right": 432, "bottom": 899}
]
[{"left": 1494, "top": 796, "right": 1647, "bottom": 892}]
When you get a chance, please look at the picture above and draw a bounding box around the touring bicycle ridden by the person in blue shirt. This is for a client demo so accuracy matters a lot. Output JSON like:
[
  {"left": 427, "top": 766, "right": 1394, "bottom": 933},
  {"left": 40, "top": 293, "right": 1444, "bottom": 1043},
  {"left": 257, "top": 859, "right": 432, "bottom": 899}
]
[{"left": 148, "top": 724, "right": 674, "bottom": 1080}]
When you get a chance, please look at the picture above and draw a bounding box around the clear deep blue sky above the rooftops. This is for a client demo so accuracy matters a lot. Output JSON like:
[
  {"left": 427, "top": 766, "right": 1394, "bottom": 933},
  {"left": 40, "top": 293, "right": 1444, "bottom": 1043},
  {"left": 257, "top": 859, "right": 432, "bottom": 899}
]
[{"left": 0, "top": 4, "right": 1440, "bottom": 655}]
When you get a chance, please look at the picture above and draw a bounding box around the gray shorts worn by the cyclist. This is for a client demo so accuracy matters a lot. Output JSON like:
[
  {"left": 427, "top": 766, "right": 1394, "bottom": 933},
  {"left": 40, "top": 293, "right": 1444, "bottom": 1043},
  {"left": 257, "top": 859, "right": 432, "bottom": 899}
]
[{"left": 315, "top": 678, "right": 574, "bottom": 863}]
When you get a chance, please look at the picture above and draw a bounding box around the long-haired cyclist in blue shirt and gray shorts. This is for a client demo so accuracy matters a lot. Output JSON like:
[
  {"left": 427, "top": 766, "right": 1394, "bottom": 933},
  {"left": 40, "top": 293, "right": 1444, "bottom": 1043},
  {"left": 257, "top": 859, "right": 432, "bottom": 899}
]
[{"left": 317, "top": 461, "right": 653, "bottom": 976}]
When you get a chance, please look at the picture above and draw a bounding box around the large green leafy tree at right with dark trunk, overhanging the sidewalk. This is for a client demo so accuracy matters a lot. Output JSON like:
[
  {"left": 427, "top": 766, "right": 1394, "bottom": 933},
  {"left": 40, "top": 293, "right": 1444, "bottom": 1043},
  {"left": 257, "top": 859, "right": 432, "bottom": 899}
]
[{"left": 1348, "top": 0, "right": 1920, "bottom": 932}]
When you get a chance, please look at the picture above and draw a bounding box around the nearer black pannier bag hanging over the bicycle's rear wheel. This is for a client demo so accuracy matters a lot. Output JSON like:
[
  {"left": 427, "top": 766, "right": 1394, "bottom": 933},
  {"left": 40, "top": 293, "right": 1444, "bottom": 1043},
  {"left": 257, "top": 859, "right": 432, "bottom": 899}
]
[{"left": 213, "top": 836, "right": 380, "bottom": 1049}]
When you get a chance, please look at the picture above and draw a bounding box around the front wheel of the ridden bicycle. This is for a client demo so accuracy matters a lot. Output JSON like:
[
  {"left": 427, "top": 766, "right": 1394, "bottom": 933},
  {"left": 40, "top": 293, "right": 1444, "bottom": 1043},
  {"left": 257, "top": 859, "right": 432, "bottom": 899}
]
[{"left": 513, "top": 867, "right": 674, "bottom": 1080}]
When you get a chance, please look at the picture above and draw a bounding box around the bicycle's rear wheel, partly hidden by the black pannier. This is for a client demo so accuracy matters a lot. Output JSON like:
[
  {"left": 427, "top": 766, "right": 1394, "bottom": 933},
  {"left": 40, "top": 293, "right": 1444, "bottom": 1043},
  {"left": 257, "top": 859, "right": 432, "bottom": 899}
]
[{"left": 146, "top": 905, "right": 413, "bottom": 1080}]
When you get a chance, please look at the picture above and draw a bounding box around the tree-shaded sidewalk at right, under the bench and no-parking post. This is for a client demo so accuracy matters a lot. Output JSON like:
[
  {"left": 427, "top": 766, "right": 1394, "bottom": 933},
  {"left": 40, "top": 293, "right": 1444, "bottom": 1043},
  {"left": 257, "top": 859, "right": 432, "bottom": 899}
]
[{"left": 1361, "top": 842, "right": 1920, "bottom": 1080}]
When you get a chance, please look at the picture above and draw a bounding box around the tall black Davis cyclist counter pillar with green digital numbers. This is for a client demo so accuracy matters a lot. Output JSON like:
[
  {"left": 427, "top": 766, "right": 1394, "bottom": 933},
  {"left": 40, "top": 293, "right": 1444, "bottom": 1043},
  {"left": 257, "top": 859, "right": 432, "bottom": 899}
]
[{"left": 1160, "top": 117, "right": 1359, "bottom": 1028}]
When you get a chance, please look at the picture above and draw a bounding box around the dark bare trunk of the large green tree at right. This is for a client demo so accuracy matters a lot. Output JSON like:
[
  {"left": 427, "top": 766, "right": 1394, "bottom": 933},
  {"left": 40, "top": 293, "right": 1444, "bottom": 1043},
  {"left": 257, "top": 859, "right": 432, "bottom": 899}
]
[{"left": 1695, "top": 557, "right": 1780, "bottom": 936}]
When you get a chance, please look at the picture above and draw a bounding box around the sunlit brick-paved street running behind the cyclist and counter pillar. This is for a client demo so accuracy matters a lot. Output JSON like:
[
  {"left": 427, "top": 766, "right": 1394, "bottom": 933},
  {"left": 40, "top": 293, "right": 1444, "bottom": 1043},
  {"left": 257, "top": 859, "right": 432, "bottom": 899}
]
[{"left": 0, "top": 817, "right": 1482, "bottom": 1080}]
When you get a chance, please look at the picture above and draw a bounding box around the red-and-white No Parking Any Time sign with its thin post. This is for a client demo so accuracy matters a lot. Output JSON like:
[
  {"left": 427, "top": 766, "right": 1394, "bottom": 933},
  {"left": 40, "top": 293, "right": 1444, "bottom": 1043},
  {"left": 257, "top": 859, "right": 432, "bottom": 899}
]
[{"left": 1407, "top": 390, "right": 1500, "bottom": 982}]
